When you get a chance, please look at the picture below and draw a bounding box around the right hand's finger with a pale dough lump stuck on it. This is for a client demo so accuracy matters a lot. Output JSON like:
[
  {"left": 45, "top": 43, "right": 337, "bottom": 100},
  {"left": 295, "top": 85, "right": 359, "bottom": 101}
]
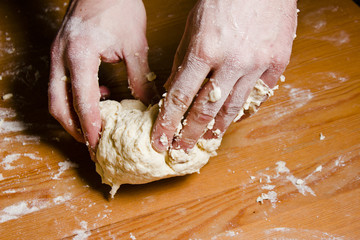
[{"left": 173, "top": 68, "right": 242, "bottom": 150}]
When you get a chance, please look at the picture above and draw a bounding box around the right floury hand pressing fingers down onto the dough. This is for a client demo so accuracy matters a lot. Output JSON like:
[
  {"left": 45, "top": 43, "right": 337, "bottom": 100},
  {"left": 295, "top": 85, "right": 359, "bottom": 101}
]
[{"left": 152, "top": 0, "right": 297, "bottom": 152}]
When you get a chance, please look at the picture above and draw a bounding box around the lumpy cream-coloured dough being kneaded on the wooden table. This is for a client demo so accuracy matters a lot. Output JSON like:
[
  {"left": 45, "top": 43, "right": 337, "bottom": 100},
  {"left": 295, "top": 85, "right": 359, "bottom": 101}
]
[{"left": 96, "top": 79, "right": 272, "bottom": 197}]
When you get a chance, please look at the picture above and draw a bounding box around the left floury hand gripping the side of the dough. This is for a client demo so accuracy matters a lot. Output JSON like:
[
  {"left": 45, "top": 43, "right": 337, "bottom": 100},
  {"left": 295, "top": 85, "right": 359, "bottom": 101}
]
[{"left": 48, "top": 0, "right": 154, "bottom": 160}]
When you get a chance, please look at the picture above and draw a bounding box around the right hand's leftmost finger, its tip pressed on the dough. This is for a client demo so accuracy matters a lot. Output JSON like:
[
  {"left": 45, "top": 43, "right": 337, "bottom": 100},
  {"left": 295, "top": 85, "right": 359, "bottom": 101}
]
[{"left": 152, "top": 58, "right": 210, "bottom": 152}]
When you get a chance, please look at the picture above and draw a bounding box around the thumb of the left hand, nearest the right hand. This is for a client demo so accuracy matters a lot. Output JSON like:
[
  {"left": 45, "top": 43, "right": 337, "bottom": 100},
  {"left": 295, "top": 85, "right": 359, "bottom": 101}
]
[{"left": 124, "top": 37, "right": 157, "bottom": 104}]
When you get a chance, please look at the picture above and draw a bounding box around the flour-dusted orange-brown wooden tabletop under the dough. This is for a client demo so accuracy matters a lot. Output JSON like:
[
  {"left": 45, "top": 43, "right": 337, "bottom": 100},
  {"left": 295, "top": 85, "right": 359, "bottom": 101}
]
[{"left": 0, "top": 0, "right": 360, "bottom": 239}]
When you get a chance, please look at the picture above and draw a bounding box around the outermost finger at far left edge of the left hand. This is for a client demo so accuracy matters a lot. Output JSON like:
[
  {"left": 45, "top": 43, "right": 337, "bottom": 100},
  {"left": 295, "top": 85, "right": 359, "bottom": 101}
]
[{"left": 48, "top": 43, "right": 84, "bottom": 142}]
